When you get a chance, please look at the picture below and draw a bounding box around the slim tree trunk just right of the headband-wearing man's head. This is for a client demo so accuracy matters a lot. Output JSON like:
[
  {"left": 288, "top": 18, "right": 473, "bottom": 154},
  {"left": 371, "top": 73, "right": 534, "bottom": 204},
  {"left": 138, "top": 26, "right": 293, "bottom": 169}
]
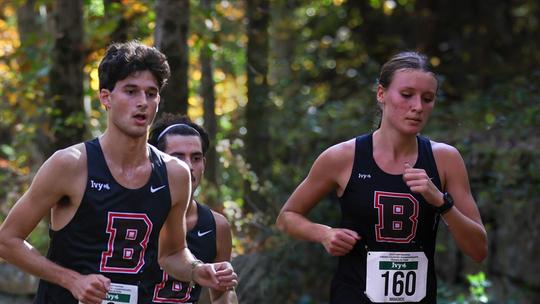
[{"left": 199, "top": 0, "right": 218, "bottom": 190}]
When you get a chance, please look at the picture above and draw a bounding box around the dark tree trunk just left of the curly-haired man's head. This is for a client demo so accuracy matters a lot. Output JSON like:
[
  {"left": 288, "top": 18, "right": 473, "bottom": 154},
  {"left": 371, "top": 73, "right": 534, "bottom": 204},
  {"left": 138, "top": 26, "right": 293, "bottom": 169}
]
[{"left": 49, "top": 0, "right": 86, "bottom": 149}]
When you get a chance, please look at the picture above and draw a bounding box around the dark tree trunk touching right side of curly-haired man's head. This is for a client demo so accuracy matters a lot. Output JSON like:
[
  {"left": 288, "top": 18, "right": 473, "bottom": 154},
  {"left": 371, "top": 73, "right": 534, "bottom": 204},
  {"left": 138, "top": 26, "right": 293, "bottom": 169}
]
[{"left": 154, "top": 0, "right": 189, "bottom": 114}]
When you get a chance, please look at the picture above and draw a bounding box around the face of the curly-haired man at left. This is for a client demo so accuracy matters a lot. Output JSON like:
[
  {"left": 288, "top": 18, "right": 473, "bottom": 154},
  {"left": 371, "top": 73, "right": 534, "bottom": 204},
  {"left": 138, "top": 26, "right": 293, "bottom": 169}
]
[{"left": 100, "top": 71, "right": 159, "bottom": 137}]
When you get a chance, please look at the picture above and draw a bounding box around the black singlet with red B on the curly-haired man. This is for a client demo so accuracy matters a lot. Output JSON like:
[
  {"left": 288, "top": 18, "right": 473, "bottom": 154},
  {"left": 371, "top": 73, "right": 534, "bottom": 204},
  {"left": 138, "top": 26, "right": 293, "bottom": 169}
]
[{"left": 34, "top": 138, "right": 171, "bottom": 304}]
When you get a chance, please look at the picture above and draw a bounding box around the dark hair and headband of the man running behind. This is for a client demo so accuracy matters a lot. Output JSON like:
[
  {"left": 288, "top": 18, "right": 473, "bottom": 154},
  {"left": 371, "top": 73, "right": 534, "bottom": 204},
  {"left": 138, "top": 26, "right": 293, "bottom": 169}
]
[{"left": 148, "top": 113, "right": 210, "bottom": 155}]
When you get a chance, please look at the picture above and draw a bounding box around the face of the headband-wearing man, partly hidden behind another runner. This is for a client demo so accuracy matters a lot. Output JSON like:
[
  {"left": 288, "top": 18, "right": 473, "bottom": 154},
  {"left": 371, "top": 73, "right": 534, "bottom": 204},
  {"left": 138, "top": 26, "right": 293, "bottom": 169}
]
[{"left": 165, "top": 134, "right": 206, "bottom": 192}]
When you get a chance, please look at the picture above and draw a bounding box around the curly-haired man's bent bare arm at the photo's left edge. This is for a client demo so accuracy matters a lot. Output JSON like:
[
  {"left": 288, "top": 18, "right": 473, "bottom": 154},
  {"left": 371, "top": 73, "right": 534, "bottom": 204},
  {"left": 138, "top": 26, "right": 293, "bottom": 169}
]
[{"left": 0, "top": 148, "right": 109, "bottom": 299}]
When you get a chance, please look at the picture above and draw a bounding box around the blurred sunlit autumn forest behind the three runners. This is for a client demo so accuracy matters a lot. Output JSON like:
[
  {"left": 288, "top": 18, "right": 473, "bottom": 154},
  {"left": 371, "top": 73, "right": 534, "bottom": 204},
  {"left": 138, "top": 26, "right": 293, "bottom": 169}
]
[{"left": 0, "top": 0, "right": 540, "bottom": 304}]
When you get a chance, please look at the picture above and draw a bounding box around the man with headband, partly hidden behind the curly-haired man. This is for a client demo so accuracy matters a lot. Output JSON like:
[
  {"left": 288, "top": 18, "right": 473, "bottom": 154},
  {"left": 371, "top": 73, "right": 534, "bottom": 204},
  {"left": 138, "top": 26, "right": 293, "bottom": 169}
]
[{"left": 149, "top": 113, "right": 238, "bottom": 304}]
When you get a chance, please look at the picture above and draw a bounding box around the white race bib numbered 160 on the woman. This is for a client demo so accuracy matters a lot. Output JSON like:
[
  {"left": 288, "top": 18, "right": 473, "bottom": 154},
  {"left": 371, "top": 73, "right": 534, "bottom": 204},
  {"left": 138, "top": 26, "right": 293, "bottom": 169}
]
[{"left": 366, "top": 251, "right": 428, "bottom": 303}]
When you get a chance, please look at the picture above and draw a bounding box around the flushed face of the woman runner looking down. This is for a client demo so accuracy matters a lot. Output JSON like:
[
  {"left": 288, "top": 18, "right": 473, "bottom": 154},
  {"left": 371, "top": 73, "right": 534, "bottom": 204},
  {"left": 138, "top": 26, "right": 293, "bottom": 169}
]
[{"left": 377, "top": 70, "right": 437, "bottom": 134}]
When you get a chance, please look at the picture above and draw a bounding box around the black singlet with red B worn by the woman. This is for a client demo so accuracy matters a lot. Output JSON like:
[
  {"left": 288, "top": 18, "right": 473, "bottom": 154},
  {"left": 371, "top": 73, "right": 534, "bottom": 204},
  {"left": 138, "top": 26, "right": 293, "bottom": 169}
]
[{"left": 330, "top": 134, "right": 441, "bottom": 304}]
